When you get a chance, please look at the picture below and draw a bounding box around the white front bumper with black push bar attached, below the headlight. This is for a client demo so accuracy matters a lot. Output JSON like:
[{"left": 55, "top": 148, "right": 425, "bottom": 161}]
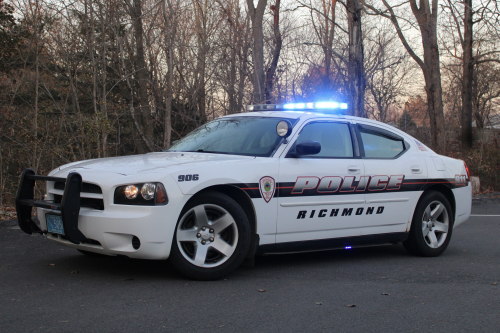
[{"left": 16, "top": 169, "right": 190, "bottom": 259}]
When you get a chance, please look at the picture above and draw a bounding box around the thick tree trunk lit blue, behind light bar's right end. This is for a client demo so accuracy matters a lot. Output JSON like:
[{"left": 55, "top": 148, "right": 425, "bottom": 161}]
[{"left": 347, "top": 0, "right": 366, "bottom": 117}]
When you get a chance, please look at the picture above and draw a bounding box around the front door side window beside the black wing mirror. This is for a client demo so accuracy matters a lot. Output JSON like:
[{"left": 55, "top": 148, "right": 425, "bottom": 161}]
[{"left": 292, "top": 121, "right": 354, "bottom": 158}]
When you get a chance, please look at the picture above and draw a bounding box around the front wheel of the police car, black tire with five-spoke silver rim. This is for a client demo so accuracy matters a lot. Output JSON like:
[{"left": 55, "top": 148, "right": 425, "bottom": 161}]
[{"left": 170, "top": 191, "right": 251, "bottom": 280}]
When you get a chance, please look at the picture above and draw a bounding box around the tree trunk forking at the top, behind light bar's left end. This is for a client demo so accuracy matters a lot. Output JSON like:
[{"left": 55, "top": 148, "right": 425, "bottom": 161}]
[{"left": 247, "top": 0, "right": 267, "bottom": 104}]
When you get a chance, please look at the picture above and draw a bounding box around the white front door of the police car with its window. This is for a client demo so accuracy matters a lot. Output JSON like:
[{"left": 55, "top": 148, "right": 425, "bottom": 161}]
[{"left": 276, "top": 119, "right": 366, "bottom": 243}]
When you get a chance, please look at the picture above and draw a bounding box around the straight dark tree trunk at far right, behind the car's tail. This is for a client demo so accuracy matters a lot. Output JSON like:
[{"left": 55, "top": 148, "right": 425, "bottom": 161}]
[{"left": 461, "top": 0, "right": 474, "bottom": 148}]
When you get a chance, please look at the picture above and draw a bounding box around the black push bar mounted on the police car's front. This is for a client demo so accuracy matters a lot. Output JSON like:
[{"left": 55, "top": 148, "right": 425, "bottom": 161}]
[{"left": 16, "top": 169, "right": 87, "bottom": 244}]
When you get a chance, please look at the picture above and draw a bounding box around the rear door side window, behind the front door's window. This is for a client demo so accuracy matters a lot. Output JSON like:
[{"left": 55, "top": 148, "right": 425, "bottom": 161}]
[{"left": 359, "top": 125, "right": 406, "bottom": 158}]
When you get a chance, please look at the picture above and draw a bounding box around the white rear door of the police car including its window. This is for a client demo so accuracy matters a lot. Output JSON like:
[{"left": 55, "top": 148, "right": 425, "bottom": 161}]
[{"left": 357, "top": 123, "right": 427, "bottom": 235}]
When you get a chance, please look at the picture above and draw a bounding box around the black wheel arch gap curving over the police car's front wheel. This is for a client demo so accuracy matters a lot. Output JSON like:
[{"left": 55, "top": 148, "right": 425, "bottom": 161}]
[{"left": 186, "top": 185, "right": 259, "bottom": 259}]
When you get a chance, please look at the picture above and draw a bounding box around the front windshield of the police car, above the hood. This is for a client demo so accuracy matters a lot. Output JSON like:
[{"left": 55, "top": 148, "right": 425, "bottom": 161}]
[{"left": 167, "top": 117, "right": 296, "bottom": 157}]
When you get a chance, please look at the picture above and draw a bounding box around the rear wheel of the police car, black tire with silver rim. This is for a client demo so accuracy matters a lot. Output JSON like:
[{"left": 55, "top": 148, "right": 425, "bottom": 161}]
[{"left": 403, "top": 191, "right": 454, "bottom": 257}]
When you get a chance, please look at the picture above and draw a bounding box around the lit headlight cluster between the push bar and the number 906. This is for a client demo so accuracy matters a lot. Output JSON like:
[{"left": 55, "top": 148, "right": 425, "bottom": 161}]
[{"left": 114, "top": 183, "right": 168, "bottom": 206}]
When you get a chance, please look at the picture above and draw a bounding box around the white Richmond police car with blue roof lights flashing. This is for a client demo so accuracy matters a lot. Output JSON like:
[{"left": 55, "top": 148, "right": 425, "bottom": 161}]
[{"left": 16, "top": 102, "right": 471, "bottom": 279}]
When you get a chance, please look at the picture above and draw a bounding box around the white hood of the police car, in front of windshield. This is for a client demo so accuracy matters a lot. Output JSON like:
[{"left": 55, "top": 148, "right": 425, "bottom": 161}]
[{"left": 50, "top": 152, "right": 255, "bottom": 176}]
